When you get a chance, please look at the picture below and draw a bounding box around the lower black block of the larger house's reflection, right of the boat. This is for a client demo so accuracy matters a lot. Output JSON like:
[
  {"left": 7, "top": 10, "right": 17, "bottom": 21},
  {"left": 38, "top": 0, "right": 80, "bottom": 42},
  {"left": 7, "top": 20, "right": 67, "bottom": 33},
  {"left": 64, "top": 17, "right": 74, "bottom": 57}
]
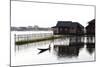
[{"left": 54, "top": 45, "right": 79, "bottom": 57}]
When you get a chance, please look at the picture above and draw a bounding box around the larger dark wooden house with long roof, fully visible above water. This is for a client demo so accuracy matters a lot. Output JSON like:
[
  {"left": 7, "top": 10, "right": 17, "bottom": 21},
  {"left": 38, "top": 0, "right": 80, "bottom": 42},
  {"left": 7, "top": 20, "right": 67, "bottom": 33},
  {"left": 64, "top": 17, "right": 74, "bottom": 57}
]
[{"left": 52, "top": 21, "right": 84, "bottom": 35}]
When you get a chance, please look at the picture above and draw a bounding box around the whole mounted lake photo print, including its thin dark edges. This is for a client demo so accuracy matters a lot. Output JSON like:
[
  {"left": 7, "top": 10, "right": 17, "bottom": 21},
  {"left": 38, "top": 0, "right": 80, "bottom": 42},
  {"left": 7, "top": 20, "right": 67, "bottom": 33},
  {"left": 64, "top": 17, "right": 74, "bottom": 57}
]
[{"left": 10, "top": 0, "right": 96, "bottom": 67}]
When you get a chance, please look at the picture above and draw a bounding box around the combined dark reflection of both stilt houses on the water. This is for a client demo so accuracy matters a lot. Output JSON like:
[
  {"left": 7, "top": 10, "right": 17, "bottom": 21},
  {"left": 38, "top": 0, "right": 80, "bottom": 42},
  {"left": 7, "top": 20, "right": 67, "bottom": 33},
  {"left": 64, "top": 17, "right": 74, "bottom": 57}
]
[{"left": 54, "top": 36, "right": 95, "bottom": 58}]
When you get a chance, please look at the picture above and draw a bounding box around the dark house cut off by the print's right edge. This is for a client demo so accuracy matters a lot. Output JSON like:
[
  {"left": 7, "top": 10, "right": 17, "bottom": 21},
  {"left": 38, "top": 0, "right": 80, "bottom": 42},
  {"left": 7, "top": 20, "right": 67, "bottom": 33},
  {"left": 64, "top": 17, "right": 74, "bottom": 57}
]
[{"left": 86, "top": 19, "right": 95, "bottom": 35}]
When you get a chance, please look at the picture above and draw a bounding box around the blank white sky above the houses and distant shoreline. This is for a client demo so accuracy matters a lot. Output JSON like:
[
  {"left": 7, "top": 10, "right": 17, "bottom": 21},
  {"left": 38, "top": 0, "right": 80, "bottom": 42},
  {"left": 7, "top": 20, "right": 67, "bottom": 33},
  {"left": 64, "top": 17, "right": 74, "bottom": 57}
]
[{"left": 11, "top": 1, "right": 95, "bottom": 27}]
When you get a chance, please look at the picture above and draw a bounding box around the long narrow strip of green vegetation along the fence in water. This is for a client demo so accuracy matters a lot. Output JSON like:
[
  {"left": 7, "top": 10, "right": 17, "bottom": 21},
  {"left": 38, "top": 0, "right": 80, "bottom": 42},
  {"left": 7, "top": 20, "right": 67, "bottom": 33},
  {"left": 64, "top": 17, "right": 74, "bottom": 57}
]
[{"left": 15, "top": 36, "right": 63, "bottom": 45}]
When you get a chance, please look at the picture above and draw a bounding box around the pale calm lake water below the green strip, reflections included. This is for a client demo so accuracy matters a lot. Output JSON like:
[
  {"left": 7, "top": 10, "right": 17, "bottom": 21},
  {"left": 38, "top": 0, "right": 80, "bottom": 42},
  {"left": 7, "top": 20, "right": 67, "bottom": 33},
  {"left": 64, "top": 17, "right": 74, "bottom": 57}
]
[{"left": 11, "top": 31, "right": 95, "bottom": 66}]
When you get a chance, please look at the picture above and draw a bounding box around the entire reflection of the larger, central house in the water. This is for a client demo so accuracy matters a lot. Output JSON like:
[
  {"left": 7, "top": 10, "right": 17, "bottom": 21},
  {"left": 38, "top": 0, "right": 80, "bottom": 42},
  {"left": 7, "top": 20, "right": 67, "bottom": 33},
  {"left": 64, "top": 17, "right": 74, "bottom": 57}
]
[{"left": 54, "top": 36, "right": 84, "bottom": 57}]
